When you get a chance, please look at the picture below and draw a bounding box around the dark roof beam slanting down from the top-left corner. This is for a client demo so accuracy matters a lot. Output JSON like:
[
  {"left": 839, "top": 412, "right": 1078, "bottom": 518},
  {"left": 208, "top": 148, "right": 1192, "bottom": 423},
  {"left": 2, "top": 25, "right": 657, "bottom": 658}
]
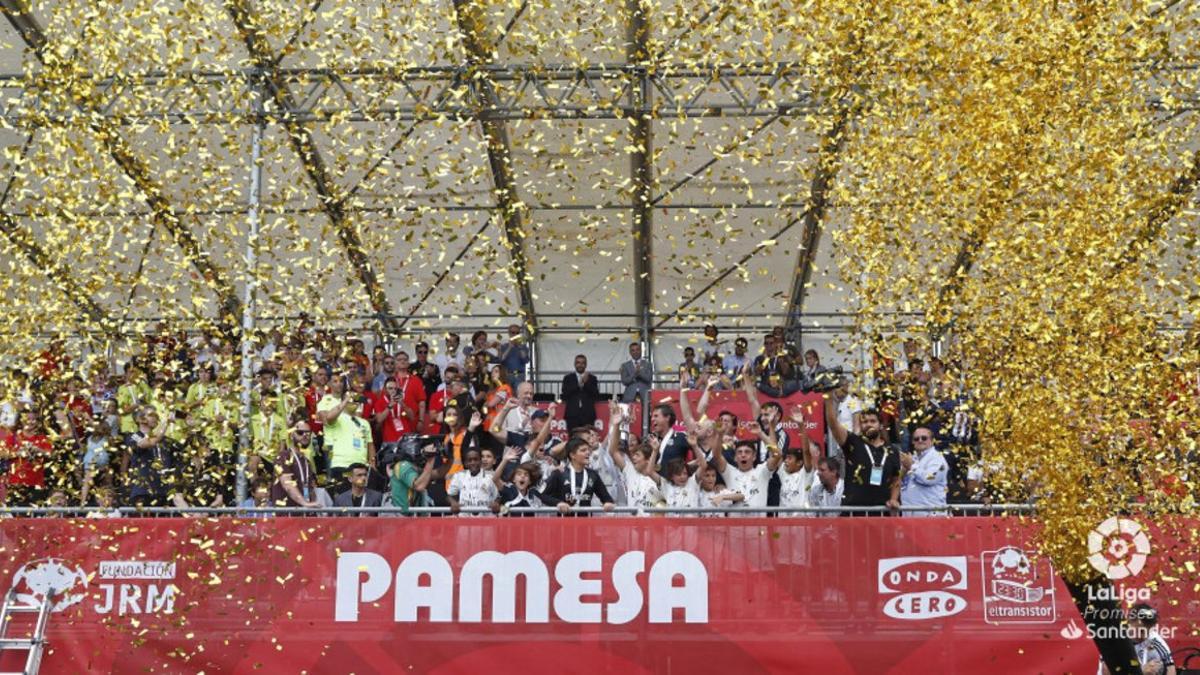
[{"left": 0, "top": 0, "right": 241, "bottom": 333}]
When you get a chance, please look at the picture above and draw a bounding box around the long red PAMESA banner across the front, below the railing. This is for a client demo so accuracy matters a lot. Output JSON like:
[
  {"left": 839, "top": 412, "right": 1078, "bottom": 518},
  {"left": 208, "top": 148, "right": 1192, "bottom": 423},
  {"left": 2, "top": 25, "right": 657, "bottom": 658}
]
[{"left": 0, "top": 516, "right": 1196, "bottom": 674}]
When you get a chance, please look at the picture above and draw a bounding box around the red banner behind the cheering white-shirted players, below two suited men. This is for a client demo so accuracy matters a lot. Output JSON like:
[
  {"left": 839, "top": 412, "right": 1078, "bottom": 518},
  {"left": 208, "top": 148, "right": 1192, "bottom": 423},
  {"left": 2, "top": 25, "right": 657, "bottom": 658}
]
[{"left": 535, "top": 389, "right": 826, "bottom": 448}]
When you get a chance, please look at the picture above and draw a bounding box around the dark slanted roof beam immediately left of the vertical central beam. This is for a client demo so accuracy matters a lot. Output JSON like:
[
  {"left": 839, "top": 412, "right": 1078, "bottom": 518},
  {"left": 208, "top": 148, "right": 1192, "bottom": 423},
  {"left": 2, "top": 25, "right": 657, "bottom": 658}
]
[{"left": 452, "top": 0, "right": 538, "bottom": 336}]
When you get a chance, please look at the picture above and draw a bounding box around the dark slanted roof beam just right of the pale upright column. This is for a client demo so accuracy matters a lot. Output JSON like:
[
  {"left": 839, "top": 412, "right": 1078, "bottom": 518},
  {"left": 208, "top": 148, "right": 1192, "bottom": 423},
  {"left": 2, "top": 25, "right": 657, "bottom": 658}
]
[{"left": 224, "top": 0, "right": 398, "bottom": 333}]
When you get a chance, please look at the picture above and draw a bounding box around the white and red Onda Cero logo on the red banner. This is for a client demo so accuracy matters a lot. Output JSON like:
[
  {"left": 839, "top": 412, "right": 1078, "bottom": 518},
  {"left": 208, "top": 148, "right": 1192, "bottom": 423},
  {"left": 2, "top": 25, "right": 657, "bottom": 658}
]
[{"left": 880, "top": 556, "right": 967, "bottom": 621}]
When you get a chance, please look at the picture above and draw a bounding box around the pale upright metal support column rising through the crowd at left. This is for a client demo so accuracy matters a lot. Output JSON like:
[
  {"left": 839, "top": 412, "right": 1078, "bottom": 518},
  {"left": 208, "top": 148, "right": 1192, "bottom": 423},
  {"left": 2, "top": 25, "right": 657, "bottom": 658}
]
[{"left": 238, "top": 86, "right": 266, "bottom": 504}]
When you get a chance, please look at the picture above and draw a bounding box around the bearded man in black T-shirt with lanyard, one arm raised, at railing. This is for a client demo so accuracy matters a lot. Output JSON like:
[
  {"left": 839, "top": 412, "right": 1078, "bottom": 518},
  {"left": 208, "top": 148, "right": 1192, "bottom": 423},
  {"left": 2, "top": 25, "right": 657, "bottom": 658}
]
[{"left": 824, "top": 394, "right": 900, "bottom": 515}]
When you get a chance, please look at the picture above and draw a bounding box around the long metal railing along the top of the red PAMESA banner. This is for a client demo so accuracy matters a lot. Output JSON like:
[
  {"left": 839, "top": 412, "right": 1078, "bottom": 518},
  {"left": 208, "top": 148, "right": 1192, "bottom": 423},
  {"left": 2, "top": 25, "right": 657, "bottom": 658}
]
[{"left": 0, "top": 503, "right": 1034, "bottom": 518}]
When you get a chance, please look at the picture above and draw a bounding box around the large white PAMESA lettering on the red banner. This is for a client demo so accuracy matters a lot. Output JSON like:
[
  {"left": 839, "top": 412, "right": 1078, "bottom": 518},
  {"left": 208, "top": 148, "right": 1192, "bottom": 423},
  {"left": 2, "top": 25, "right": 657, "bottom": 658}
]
[{"left": 334, "top": 550, "right": 709, "bottom": 625}]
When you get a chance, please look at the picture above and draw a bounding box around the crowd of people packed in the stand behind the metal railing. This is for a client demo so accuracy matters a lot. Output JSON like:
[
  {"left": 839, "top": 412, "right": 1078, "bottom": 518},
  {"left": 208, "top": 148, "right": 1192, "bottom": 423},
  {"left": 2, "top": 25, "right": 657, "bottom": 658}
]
[{"left": 0, "top": 323, "right": 980, "bottom": 516}]
